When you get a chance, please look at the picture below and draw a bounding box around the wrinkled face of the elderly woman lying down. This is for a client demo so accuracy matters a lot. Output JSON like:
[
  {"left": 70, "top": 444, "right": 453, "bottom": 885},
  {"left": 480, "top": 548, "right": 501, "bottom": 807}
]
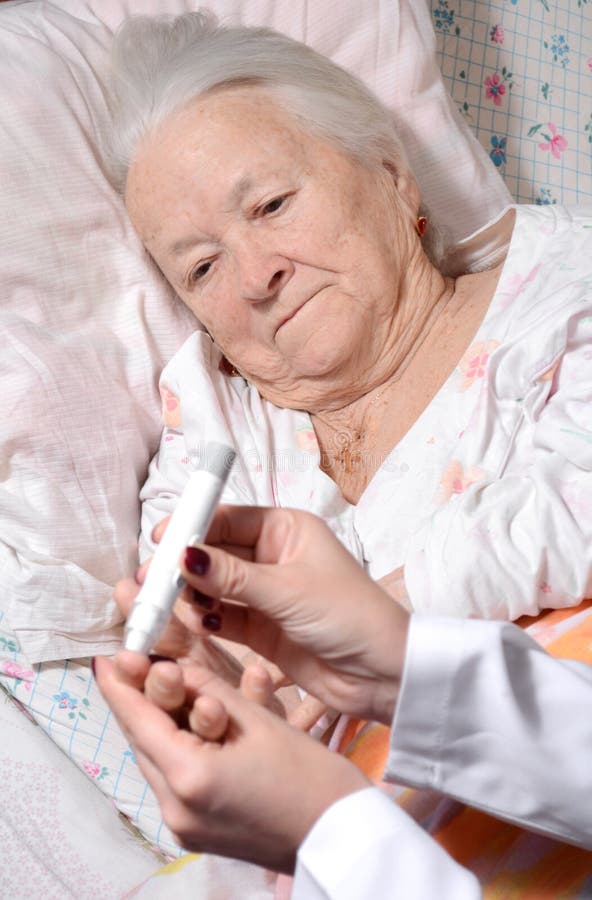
[{"left": 126, "top": 87, "right": 416, "bottom": 409}]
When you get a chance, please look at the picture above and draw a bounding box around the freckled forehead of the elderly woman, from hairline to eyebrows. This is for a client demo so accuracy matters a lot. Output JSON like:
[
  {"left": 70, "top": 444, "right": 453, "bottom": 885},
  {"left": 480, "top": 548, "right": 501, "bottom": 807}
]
[{"left": 126, "top": 86, "right": 340, "bottom": 234}]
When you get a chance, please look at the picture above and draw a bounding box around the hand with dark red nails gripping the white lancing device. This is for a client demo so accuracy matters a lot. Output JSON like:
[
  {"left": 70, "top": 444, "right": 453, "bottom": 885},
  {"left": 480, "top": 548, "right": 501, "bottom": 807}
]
[{"left": 175, "top": 506, "right": 409, "bottom": 724}]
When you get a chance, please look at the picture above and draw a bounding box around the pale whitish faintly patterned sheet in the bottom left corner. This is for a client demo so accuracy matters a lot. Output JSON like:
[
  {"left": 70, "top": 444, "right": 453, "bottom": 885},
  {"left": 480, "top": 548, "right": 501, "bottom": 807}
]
[{"left": 0, "top": 688, "right": 163, "bottom": 900}]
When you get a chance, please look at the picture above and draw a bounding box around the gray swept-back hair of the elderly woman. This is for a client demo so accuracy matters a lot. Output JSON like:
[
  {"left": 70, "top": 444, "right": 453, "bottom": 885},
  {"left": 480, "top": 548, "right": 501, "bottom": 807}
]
[{"left": 107, "top": 12, "right": 439, "bottom": 258}]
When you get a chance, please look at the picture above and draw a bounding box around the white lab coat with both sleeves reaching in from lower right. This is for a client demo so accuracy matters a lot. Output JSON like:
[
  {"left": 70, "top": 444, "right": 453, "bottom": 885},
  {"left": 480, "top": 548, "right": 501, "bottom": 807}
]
[{"left": 293, "top": 615, "right": 592, "bottom": 900}]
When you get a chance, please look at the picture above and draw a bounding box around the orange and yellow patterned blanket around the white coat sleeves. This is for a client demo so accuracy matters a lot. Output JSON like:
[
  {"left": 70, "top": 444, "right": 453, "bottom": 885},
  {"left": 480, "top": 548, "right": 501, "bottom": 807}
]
[{"left": 340, "top": 600, "right": 592, "bottom": 900}]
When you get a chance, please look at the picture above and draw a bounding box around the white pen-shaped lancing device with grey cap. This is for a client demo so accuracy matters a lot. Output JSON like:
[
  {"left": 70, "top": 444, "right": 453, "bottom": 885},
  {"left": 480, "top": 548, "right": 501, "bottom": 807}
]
[{"left": 123, "top": 441, "right": 236, "bottom": 653}]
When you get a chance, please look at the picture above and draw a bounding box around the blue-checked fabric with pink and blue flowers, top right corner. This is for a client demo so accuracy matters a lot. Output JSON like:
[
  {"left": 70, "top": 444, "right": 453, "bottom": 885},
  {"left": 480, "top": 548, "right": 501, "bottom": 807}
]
[{"left": 431, "top": 0, "right": 592, "bottom": 204}]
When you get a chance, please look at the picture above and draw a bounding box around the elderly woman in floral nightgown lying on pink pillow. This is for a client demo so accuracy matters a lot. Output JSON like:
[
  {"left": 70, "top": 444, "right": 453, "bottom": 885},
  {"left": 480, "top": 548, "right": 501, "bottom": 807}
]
[{"left": 2, "top": 5, "right": 592, "bottom": 864}]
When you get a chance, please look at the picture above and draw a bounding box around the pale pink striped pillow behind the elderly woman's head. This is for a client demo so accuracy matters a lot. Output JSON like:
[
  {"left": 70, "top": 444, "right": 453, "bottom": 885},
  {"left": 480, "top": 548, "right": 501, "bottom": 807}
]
[{"left": 0, "top": 0, "right": 509, "bottom": 663}]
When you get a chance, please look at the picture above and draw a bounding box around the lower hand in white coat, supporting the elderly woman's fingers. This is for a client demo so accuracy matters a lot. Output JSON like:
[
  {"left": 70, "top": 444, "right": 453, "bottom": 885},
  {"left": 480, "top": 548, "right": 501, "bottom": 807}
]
[{"left": 95, "top": 654, "right": 370, "bottom": 872}]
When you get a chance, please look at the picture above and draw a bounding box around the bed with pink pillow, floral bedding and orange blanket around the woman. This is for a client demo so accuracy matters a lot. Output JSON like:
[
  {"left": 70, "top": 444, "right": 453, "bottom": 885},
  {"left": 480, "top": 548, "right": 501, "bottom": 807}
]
[{"left": 0, "top": 0, "right": 592, "bottom": 900}]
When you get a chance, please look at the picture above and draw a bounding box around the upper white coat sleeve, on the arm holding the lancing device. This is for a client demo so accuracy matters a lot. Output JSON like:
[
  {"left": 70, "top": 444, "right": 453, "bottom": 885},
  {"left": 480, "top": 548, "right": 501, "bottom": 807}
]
[{"left": 385, "top": 616, "right": 592, "bottom": 849}]
